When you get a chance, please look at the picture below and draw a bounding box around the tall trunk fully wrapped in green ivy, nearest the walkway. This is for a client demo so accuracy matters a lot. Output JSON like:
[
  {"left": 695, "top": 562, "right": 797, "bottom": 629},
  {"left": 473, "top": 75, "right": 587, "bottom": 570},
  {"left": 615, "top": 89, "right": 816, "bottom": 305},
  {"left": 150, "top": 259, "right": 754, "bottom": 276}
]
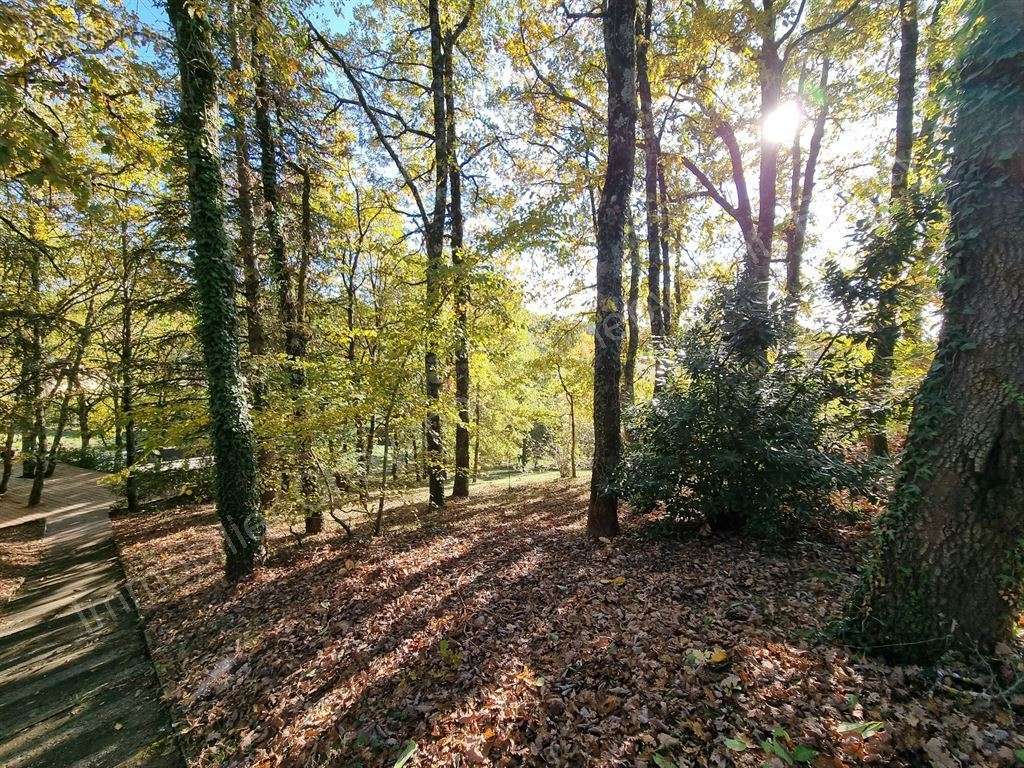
[{"left": 167, "top": 0, "right": 265, "bottom": 581}]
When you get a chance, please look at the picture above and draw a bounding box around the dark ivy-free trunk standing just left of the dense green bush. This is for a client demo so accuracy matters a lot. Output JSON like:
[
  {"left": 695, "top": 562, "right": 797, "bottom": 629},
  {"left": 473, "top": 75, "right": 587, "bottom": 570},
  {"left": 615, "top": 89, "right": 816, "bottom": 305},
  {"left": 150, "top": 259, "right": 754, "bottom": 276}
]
[{"left": 587, "top": 0, "right": 637, "bottom": 537}]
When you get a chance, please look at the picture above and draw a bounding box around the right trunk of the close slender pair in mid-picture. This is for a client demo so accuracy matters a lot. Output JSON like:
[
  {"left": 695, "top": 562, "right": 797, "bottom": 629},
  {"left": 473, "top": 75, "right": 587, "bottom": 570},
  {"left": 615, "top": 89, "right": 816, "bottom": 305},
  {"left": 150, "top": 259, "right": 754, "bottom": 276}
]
[{"left": 444, "top": 44, "right": 470, "bottom": 499}]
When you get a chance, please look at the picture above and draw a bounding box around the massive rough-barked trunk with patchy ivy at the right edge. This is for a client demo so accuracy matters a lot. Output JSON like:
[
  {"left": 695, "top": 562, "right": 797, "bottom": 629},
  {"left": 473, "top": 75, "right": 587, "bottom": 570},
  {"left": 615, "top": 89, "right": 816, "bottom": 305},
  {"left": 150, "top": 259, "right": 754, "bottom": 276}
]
[{"left": 850, "top": 0, "right": 1024, "bottom": 662}]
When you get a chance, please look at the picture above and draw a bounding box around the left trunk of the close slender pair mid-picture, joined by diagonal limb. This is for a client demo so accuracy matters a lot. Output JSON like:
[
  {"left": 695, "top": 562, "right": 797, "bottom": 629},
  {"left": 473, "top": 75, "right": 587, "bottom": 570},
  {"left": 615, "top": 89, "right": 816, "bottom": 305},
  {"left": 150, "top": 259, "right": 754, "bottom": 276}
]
[{"left": 424, "top": 0, "right": 450, "bottom": 509}]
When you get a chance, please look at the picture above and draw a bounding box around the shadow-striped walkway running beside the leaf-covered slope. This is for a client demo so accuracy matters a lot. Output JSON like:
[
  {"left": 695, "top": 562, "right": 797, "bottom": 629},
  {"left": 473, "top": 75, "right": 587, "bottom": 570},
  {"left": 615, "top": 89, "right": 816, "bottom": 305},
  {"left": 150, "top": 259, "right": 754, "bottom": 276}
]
[{"left": 0, "top": 465, "right": 182, "bottom": 768}]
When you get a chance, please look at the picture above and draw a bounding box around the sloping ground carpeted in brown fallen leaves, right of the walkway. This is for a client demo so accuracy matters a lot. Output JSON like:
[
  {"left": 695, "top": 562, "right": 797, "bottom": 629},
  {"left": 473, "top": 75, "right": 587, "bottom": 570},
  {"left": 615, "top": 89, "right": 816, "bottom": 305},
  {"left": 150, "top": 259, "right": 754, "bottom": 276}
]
[{"left": 115, "top": 481, "right": 1024, "bottom": 768}]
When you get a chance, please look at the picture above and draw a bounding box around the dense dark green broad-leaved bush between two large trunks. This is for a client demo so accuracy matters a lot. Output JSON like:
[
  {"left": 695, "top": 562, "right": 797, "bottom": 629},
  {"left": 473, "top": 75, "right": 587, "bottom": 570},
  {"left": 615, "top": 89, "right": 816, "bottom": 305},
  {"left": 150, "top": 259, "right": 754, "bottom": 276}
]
[{"left": 617, "top": 295, "right": 867, "bottom": 538}]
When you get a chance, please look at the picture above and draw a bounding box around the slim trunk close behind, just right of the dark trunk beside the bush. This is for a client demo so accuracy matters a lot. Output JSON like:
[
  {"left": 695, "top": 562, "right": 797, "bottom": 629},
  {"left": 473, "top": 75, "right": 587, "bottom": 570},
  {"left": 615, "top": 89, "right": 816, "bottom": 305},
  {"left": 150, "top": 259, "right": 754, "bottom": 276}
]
[{"left": 634, "top": 0, "right": 665, "bottom": 382}]
